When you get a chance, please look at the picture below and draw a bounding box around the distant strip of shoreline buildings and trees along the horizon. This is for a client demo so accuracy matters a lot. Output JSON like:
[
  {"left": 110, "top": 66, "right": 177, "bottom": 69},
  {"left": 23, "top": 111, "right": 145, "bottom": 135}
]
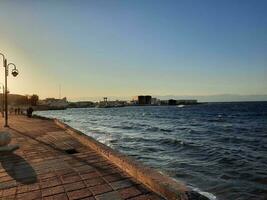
[{"left": 3, "top": 94, "right": 199, "bottom": 113}]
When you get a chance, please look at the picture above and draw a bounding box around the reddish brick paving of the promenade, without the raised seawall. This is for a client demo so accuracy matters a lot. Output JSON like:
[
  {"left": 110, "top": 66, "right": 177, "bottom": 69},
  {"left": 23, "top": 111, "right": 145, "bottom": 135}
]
[{"left": 0, "top": 116, "right": 162, "bottom": 200}]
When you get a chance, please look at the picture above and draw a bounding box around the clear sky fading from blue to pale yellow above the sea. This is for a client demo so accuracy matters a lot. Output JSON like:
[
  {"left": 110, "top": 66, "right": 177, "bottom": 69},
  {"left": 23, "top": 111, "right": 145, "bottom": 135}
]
[{"left": 0, "top": 0, "right": 267, "bottom": 100}]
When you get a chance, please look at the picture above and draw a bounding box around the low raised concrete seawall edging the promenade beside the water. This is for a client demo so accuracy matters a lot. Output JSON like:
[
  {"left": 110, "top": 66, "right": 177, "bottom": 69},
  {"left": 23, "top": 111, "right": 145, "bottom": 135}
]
[{"left": 51, "top": 117, "right": 208, "bottom": 200}]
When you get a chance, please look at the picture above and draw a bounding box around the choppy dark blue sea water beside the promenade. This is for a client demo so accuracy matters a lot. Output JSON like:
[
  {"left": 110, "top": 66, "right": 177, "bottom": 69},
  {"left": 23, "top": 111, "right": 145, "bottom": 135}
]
[{"left": 36, "top": 102, "right": 267, "bottom": 200}]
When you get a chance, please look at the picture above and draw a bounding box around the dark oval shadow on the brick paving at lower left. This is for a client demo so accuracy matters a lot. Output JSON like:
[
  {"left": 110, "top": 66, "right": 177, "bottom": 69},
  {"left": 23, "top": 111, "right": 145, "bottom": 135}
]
[{"left": 0, "top": 153, "right": 37, "bottom": 184}]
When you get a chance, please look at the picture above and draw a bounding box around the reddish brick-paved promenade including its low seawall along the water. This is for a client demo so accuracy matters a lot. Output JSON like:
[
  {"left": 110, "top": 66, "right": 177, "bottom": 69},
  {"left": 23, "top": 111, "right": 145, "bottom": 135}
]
[{"left": 0, "top": 116, "right": 206, "bottom": 200}]
